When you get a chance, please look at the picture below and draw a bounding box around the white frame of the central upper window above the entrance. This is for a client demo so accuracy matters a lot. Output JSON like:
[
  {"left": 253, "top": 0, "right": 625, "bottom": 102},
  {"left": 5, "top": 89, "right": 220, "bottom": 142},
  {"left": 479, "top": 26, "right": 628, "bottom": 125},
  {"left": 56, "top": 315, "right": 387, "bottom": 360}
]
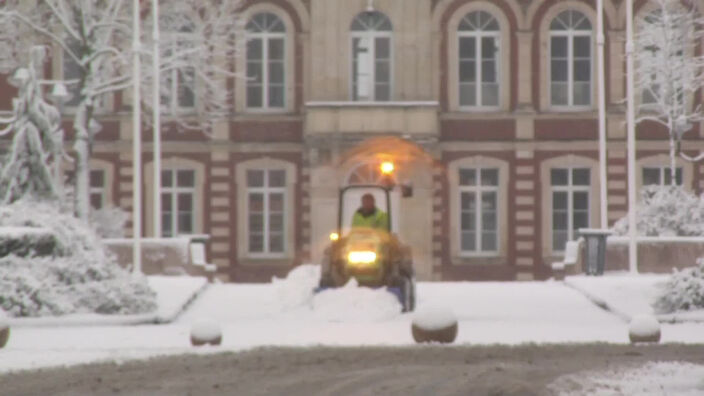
[{"left": 349, "top": 14, "right": 394, "bottom": 103}]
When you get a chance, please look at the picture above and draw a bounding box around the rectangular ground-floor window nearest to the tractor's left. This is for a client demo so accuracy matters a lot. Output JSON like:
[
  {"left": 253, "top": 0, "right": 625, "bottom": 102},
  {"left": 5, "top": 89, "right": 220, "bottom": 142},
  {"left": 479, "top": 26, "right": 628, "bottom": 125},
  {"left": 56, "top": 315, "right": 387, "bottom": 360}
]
[{"left": 246, "top": 169, "right": 286, "bottom": 255}]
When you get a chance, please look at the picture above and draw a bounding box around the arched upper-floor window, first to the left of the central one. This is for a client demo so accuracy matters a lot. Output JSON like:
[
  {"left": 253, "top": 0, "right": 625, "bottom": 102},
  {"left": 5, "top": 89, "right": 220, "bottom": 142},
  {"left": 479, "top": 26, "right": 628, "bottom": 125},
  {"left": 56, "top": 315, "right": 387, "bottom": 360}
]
[{"left": 246, "top": 12, "right": 286, "bottom": 110}]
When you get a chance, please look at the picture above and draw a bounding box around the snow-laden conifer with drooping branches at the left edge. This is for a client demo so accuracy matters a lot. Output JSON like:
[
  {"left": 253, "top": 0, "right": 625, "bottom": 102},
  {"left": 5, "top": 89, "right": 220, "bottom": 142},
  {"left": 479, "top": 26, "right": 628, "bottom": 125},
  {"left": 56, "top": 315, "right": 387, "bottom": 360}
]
[{"left": 0, "top": 47, "right": 64, "bottom": 204}]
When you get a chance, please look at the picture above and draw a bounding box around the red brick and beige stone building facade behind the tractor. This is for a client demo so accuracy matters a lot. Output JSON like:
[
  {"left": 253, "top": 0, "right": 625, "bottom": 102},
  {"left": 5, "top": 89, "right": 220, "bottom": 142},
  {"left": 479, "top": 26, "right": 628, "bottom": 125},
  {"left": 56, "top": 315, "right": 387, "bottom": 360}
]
[{"left": 2, "top": 0, "right": 704, "bottom": 282}]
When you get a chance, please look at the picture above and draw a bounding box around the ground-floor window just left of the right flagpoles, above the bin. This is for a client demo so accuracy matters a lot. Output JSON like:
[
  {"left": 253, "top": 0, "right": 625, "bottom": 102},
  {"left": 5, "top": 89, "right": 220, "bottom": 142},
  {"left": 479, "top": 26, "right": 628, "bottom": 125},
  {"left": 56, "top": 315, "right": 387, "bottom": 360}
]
[{"left": 550, "top": 168, "right": 591, "bottom": 252}]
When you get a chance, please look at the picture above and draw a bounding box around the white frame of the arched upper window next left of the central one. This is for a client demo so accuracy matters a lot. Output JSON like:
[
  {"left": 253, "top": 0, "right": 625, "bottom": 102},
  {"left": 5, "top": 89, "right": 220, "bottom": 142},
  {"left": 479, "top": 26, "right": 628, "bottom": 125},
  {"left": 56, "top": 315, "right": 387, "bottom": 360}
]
[{"left": 244, "top": 11, "right": 288, "bottom": 113}]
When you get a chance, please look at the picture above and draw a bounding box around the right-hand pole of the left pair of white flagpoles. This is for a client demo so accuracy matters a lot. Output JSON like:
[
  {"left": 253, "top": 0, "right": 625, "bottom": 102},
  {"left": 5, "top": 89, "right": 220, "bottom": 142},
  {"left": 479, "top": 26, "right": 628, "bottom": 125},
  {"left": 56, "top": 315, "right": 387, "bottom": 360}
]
[{"left": 152, "top": 0, "right": 161, "bottom": 238}]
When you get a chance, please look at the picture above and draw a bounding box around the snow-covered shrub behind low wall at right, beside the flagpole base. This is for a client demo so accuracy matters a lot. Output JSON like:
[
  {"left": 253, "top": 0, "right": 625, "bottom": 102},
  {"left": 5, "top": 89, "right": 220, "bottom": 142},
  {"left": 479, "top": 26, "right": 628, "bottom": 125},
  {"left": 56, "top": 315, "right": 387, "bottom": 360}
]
[{"left": 613, "top": 186, "right": 704, "bottom": 236}]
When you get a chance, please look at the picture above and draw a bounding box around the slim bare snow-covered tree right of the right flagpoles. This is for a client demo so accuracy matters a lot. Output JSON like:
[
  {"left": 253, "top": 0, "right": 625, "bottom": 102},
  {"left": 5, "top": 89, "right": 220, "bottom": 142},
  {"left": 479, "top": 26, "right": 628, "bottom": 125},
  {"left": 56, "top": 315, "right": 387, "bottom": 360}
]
[{"left": 634, "top": 0, "right": 704, "bottom": 184}]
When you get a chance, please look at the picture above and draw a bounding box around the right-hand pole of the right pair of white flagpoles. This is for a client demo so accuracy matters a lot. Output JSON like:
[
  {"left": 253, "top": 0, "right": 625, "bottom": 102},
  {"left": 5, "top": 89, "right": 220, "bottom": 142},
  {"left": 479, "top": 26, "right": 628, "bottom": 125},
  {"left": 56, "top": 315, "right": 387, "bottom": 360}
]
[{"left": 626, "top": 0, "right": 638, "bottom": 273}]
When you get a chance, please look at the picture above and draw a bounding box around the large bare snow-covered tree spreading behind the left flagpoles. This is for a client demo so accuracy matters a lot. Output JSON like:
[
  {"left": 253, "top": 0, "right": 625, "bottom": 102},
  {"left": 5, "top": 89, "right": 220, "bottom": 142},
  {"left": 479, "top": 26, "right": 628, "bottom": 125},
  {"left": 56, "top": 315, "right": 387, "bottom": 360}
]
[{"left": 0, "top": 0, "right": 240, "bottom": 220}]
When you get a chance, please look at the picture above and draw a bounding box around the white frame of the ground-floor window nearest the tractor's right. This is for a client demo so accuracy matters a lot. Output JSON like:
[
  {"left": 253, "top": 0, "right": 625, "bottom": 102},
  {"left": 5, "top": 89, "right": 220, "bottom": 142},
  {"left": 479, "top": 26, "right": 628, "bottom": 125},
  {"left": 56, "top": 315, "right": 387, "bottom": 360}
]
[{"left": 457, "top": 166, "right": 501, "bottom": 257}]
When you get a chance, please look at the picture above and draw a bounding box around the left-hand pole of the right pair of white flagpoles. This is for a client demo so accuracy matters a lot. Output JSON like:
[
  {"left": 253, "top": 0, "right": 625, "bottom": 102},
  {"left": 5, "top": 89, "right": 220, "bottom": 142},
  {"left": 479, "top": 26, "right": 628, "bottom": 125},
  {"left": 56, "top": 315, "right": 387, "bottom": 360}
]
[{"left": 596, "top": 0, "right": 609, "bottom": 229}]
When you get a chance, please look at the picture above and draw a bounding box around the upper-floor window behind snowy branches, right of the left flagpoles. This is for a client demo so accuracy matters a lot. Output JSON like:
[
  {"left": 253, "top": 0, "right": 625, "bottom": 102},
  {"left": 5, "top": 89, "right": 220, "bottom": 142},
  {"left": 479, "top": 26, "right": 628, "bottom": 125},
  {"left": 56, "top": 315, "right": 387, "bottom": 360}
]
[{"left": 161, "top": 18, "right": 196, "bottom": 114}]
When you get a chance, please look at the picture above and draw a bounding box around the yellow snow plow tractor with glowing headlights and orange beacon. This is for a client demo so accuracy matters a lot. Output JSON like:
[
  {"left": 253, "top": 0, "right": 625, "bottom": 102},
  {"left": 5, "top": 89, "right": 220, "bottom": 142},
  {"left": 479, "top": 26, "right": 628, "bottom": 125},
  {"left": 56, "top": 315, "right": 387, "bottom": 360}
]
[{"left": 317, "top": 161, "right": 416, "bottom": 312}]
